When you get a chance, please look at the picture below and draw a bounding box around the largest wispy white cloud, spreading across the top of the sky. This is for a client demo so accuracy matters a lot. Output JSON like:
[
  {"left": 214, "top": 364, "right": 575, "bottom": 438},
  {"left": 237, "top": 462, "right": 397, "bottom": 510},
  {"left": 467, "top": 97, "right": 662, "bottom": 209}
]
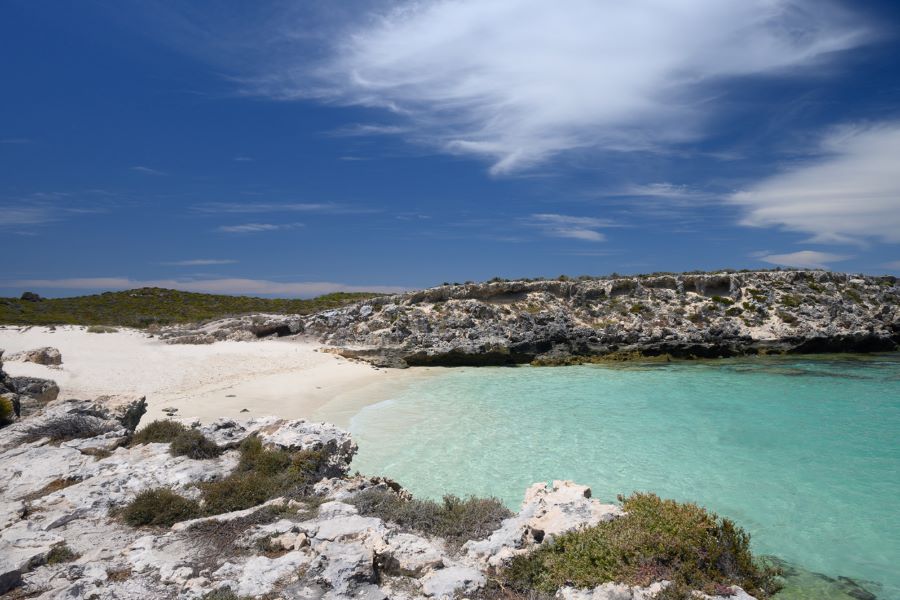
[{"left": 247, "top": 0, "right": 872, "bottom": 174}]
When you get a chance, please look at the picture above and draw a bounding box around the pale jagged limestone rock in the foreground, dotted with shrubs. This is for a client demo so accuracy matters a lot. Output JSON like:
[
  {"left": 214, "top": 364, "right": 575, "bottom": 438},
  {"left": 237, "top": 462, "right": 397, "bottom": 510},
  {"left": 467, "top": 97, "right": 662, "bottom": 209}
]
[{"left": 0, "top": 398, "right": 760, "bottom": 600}]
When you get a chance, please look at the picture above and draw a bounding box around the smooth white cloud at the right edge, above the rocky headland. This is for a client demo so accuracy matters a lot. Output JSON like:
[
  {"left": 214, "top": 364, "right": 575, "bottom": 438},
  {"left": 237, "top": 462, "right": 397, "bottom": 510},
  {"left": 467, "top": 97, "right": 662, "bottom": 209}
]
[{"left": 731, "top": 122, "right": 900, "bottom": 243}]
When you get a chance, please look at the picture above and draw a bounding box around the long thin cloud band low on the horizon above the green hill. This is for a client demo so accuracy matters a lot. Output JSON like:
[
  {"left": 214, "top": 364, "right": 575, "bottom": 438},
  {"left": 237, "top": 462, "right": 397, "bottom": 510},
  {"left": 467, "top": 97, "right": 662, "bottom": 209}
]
[{"left": 4, "top": 277, "right": 406, "bottom": 296}]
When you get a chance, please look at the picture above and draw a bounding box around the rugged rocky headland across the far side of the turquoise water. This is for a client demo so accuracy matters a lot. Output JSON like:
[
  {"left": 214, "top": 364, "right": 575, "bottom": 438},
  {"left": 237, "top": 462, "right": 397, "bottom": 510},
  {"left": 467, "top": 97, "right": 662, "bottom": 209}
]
[{"left": 162, "top": 271, "right": 900, "bottom": 367}]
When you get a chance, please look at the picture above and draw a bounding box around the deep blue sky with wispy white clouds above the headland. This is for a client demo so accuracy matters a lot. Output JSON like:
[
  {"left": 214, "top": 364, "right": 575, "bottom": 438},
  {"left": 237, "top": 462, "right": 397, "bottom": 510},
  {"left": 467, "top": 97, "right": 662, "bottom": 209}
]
[{"left": 0, "top": 0, "right": 900, "bottom": 297}]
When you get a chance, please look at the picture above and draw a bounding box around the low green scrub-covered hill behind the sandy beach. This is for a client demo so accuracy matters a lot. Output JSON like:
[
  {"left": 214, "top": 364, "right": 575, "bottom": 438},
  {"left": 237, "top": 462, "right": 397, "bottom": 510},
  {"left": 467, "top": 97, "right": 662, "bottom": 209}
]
[{"left": 0, "top": 288, "right": 377, "bottom": 333}]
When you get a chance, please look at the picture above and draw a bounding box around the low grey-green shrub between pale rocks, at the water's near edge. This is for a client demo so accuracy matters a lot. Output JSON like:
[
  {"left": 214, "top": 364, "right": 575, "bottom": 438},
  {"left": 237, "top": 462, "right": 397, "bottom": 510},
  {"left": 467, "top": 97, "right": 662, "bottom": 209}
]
[{"left": 350, "top": 489, "right": 512, "bottom": 546}]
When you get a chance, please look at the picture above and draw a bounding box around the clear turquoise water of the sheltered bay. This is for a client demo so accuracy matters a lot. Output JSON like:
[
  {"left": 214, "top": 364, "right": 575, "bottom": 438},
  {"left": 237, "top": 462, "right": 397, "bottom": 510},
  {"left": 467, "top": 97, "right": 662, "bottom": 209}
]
[{"left": 350, "top": 355, "right": 900, "bottom": 600}]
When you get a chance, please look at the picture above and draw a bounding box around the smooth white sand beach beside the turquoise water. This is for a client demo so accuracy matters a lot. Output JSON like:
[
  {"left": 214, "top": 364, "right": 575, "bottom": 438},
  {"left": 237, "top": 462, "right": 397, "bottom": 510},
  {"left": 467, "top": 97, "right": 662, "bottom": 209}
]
[{"left": 0, "top": 327, "right": 415, "bottom": 425}]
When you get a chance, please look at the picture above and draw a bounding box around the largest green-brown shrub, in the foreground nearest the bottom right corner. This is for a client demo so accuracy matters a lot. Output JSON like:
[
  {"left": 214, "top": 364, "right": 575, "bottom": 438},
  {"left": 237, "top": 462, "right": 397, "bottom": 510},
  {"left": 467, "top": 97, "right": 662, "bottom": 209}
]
[{"left": 501, "top": 493, "right": 778, "bottom": 598}]
